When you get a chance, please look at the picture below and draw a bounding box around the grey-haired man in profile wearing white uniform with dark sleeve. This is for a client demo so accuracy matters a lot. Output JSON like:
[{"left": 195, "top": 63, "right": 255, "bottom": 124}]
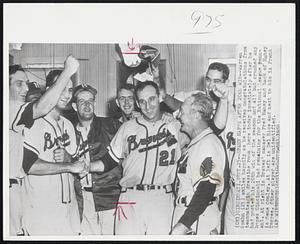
[{"left": 171, "top": 93, "right": 226, "bottom": 235}]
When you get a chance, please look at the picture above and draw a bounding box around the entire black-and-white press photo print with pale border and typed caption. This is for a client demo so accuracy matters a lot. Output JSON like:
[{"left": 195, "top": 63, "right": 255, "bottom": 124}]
[{"left": 3, "top": 4, "right": 295, "bottom": 240}]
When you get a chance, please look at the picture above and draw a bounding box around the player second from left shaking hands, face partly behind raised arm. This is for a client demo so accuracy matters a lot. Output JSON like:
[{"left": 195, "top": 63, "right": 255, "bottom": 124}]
[{"left": 23, "top": 69, "right": 87, "bottom": 235}]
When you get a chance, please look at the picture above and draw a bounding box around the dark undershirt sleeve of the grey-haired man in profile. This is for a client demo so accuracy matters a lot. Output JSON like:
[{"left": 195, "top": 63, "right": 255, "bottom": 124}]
[{"left": 179, "top": 181, "right": 216, "bottom": 228}]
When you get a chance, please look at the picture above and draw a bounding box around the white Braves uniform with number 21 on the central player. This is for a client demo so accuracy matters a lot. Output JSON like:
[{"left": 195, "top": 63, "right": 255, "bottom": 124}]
[{"left": 108, "top": 117, "right": 180, "bottom": 235}]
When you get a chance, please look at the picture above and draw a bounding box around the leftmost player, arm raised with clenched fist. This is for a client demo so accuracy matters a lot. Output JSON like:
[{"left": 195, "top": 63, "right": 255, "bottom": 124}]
[{"left": 9, "top": 56, "right": 78, "bottom": 235}]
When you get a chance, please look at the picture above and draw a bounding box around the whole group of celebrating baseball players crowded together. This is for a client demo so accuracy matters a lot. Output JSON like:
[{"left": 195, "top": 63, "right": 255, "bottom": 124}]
[{"left": 9, "top": 55, "right": 236, "bottom": 236}]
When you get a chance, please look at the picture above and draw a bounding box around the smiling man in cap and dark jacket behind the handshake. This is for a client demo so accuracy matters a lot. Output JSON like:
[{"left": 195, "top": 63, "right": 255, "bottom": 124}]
[{"left": 72, "top": 84, "right": 122, "bottom": 235}]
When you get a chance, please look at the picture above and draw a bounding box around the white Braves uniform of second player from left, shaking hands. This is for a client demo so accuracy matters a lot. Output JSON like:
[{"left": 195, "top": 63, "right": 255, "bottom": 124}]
[{"left": 23, "top": 114, "right": 80, "bottom": 235}]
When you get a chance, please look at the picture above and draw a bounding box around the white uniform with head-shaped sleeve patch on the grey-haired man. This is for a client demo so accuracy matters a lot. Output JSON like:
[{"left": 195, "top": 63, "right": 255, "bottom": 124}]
[{"left": 173, "top": 128, "right": 226, "bottom": 235}]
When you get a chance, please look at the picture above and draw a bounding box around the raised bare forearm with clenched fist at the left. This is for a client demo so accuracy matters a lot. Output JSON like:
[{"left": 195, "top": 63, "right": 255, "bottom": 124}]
[{"left": 33, "top": 55, "right": 79, "bottom": 119}]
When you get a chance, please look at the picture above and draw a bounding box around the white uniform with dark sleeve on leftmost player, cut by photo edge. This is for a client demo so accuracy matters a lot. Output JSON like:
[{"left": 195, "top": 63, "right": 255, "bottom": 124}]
[{"left": 9, "top": 100, "right": 33, "bottom": 235}]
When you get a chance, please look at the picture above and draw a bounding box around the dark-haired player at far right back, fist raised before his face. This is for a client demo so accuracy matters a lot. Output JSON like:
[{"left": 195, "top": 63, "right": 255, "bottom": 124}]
[{"left": 159, "top": 62, "right": 237, "bottom": 234}]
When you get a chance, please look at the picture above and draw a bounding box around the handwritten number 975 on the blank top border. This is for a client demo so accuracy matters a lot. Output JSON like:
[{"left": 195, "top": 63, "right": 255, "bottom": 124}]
[{"left": 191, "top": 10, "right": 224, "bottom": 28}]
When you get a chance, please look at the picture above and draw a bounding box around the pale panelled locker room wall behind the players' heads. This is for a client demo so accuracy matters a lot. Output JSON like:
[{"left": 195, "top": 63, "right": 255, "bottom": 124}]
[{"left": 11, "top": 43, "right": 236, "bottom": 116}]
